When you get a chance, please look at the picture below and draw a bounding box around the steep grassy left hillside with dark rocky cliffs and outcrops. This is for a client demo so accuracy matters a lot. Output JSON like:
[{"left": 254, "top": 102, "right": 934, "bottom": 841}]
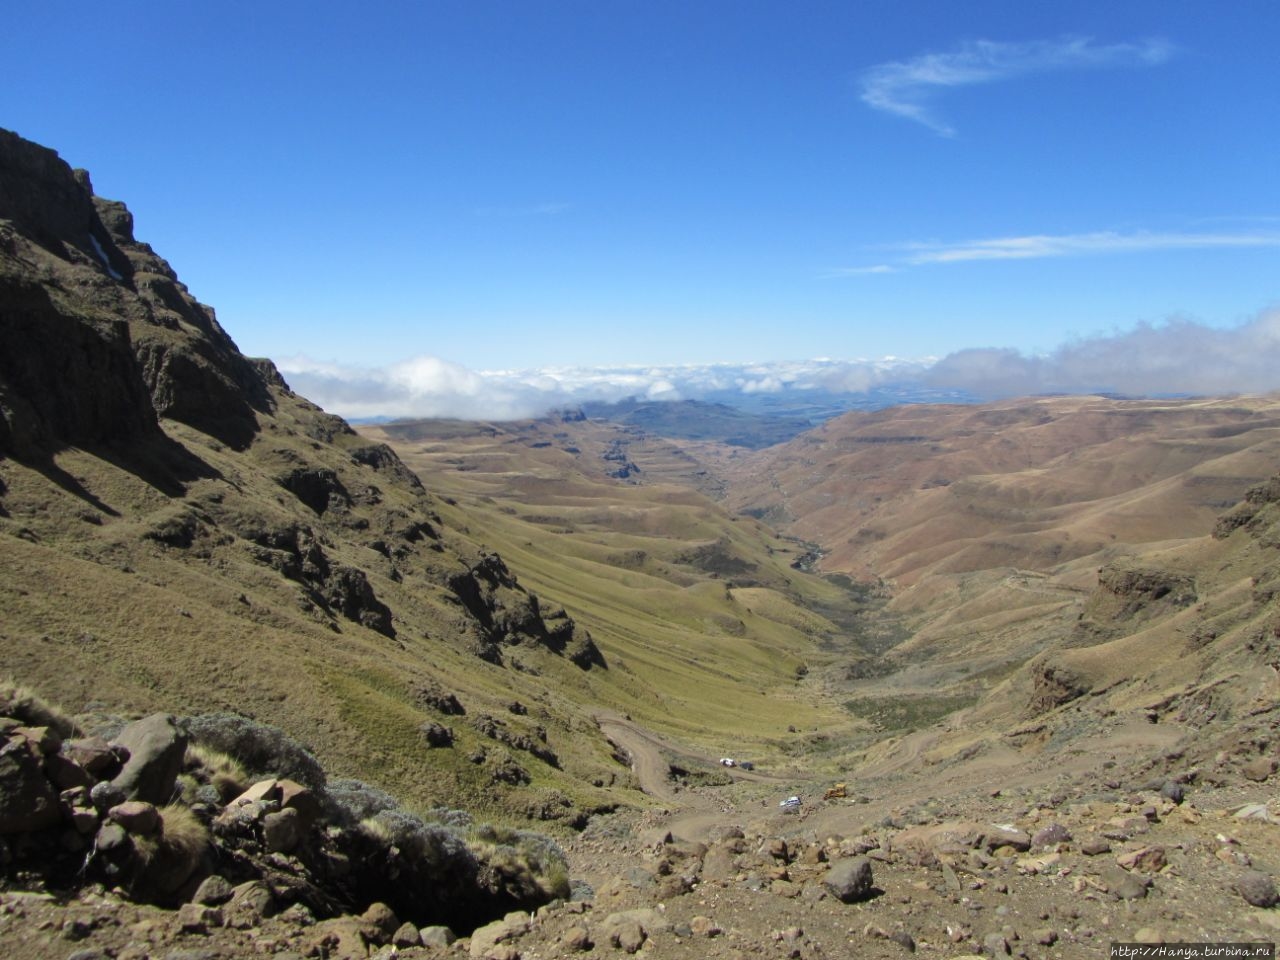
[{"left": 0, "top": 132, "right": 625, "bottom": 819}]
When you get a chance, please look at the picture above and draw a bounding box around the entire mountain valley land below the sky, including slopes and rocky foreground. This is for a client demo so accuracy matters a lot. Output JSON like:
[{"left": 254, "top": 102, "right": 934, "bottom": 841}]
[{"left": 0, "top": 132, "right": 1280, "bottom": 960}]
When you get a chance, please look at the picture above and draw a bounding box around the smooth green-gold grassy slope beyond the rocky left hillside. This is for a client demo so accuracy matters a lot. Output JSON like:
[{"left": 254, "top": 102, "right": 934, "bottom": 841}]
[{"left": 361, "top": 417, "right": 874, "bottom": 765}]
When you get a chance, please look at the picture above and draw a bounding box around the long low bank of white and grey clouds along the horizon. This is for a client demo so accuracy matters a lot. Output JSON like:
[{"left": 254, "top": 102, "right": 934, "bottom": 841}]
[{"left": 279, "top": 307, "right": 1280, "bottom": 420}]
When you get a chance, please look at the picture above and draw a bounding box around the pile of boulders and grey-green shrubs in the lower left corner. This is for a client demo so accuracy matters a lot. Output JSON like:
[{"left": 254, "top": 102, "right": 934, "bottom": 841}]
[{"left": 0, "top": 714, "right": 567, "bottom": 940}]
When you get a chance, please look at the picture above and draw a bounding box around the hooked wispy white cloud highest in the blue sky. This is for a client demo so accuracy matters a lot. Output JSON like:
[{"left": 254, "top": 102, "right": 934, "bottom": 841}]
[{"left": 861, "top": 37, "right": 1174, "bottom": 137}]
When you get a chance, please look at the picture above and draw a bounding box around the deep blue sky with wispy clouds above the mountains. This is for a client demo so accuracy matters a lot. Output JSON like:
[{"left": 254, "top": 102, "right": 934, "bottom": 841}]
[{"left": 0, "top": 0, "right": 1280, "bottom": 412}]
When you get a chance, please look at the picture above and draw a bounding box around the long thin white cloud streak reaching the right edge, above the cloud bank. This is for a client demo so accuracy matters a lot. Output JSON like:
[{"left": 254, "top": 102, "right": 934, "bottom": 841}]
[{"left": 823, "top": 230, "right": 1280, "bottom": 278}]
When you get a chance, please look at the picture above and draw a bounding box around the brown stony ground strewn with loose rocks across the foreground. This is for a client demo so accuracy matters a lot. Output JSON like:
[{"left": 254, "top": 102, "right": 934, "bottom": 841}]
[{"left": 0, "top": 686, "right": 1280, "bottom": 960}]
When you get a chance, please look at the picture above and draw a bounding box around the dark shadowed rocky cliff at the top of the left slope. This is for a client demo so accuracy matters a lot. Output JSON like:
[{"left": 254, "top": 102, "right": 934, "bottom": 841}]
[{"left": 0, "top": 131, "right": 270, "bottom": 457}]
